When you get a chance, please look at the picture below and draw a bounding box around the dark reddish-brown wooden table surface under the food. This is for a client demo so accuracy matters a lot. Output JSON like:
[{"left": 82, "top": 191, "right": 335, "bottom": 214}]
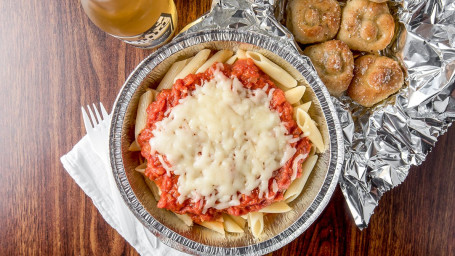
[{"left": 0, "top": 0, "right": 455, "bottom": 255}]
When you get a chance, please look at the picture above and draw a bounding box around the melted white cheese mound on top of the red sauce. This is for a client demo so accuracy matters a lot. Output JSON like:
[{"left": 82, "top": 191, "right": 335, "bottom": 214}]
[{"left": 150, "top": 71, "right": 296, "bottom": 212}]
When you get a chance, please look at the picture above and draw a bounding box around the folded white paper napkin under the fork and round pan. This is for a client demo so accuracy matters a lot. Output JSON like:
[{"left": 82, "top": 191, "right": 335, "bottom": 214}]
[{"left": 60, "top": 120, "right": 188, "bottom": 256}]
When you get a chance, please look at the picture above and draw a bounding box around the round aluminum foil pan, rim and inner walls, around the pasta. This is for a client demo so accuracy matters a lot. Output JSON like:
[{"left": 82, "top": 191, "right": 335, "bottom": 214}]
[{"left": 109, "top": 30, "right": 344, "bottom": 255}]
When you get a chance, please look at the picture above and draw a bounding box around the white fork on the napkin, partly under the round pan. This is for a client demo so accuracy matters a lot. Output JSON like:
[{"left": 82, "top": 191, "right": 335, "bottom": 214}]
[{"left": 81, "top": 102, "right": 157, "bottom": 248}]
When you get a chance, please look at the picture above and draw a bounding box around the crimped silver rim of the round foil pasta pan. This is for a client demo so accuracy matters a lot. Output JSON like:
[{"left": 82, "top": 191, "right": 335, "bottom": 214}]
[{"left": 109, "top": 30, "right": 344, "bottom": 255}]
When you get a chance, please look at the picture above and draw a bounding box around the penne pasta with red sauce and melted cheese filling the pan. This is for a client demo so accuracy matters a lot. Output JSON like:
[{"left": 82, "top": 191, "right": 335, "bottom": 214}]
[{"left": 130, "top": 50, "right": 324, "bottom": 238}]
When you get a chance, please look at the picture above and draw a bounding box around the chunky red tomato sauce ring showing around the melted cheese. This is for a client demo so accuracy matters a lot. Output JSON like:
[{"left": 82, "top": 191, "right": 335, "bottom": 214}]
[{"left": 138, "top": 59, "right": 311, "bottom": 223}]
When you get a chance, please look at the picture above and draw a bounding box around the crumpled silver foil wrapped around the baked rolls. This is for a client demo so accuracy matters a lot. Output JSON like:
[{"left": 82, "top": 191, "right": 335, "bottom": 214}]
[{"left": 181, "top": 0, "right": 455, "bottom": 229}]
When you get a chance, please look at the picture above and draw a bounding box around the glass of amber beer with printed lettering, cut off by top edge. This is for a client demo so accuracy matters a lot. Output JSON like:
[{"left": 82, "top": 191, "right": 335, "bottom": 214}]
[{"left": 81, "top": 0, "right": 177, "bottom": 48}]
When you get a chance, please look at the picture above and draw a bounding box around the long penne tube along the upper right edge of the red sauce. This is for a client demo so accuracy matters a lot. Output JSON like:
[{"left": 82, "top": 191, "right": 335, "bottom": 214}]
[{"left": 246, "top": 51, "right": 297, "bottom": 88}]
